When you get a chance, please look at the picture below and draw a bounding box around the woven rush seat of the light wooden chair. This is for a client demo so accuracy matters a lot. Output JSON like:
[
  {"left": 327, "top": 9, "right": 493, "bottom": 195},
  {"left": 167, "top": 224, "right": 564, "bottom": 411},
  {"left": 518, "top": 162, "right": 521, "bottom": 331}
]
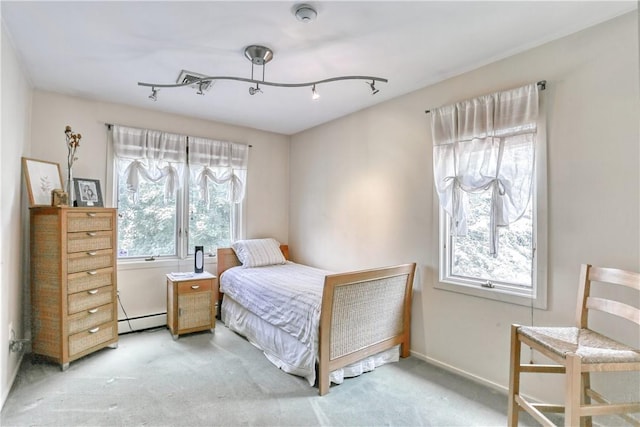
[{"left": 518, "top": 326, "right": 640, "bottom": 364}]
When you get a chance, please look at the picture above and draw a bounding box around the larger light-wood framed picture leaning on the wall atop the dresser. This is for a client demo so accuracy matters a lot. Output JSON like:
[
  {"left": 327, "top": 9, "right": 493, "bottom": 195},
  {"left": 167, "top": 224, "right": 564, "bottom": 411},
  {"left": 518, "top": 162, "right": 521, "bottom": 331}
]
[{"left": 22, "top": 157, "right": 62, "bottom": 206}]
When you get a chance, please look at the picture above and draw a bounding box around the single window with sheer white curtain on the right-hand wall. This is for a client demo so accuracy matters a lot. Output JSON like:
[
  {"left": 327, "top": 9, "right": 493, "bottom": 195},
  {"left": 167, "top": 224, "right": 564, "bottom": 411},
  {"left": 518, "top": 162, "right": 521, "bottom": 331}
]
[{"left": 431, "top": 84, "right": 546, "bottom": 308}]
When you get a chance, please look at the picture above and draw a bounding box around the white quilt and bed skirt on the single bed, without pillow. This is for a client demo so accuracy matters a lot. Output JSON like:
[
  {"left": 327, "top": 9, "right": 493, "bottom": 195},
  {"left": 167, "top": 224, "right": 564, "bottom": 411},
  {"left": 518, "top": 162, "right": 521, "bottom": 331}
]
[{"left": 220, "top": 262, "right": 399, "bottom": 385}]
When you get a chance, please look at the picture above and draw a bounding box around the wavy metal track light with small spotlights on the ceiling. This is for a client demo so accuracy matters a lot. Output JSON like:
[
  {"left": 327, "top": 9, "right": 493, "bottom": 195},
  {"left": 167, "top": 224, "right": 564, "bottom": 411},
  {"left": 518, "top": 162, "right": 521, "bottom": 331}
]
[{"left": 138, "top": 45, "right": 388, "bottom": 101}]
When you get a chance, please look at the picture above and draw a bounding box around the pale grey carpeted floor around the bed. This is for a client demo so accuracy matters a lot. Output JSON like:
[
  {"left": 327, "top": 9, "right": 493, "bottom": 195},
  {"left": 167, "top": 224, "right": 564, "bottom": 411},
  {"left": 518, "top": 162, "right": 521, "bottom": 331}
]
[{"left": 0, "top": 323, "right": 535, "bottom": 426}]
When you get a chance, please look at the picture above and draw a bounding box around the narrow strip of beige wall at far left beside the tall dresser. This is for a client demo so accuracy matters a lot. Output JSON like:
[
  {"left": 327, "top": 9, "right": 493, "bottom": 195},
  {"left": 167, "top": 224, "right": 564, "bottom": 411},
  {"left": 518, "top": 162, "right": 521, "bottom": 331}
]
[{"left": 0, "top": 23, "right": 31, "bottom": 406}]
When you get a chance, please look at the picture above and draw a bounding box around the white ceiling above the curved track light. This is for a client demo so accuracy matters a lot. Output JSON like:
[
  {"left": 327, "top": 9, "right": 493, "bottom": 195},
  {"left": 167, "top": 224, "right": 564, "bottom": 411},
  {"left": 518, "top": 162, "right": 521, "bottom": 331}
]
[{"left": 0, "top": 0, "right": 637, "bottom": 134}]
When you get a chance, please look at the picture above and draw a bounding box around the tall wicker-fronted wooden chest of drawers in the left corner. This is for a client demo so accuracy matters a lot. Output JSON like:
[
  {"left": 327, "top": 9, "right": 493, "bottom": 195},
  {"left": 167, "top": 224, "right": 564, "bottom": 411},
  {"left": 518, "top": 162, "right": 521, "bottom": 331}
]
[{"left": 30, "top": 207, "right": 118, "bottom": 370}]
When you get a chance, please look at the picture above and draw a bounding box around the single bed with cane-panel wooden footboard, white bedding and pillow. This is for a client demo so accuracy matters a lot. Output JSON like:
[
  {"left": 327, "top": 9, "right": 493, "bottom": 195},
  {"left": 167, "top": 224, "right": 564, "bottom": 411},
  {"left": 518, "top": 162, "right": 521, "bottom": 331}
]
[{"left": 217, "top": 239, "right": 416, "bottom": 395}]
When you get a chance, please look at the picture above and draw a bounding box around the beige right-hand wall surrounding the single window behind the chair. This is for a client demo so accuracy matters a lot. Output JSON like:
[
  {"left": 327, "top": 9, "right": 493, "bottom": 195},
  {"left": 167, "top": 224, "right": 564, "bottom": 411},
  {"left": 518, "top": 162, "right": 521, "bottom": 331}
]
[{"left": 289, "top": 12, "right": 640, "bottom": 402}]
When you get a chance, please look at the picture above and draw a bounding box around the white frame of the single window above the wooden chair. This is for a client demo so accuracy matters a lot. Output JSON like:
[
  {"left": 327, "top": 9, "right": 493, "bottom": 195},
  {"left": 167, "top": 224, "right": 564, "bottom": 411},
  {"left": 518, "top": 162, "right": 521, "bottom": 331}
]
[{"left": 434, "top": 97, "right": 548, "bottom": 310}]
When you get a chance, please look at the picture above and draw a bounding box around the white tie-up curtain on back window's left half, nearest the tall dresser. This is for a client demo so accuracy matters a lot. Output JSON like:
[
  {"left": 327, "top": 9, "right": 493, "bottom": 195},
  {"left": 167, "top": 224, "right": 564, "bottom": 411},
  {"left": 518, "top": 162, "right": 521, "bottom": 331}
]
[{"left": 112, "top": 125, "right": 187, "bottom": 200}]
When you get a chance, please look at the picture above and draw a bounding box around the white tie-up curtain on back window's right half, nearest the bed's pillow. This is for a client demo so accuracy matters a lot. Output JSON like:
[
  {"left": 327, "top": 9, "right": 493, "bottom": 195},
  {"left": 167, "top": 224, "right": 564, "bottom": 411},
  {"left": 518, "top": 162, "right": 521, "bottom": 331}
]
[{"left": 189, "top": 137, "right": 249, "bottom": 205}]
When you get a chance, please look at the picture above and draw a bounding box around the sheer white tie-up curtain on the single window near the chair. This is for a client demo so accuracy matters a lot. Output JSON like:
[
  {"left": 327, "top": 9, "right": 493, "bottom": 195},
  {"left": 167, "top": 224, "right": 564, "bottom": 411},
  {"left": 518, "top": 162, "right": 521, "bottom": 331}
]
[{"left": 431, "top": 83, "right": 538, "bottom": 256}]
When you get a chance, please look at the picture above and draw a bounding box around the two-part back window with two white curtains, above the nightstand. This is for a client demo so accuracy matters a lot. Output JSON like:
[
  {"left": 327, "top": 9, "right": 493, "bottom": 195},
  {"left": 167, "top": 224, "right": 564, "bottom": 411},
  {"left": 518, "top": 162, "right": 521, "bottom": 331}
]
[{"left": 111, "top": 125, "right": 248, "bottom": 259}]
